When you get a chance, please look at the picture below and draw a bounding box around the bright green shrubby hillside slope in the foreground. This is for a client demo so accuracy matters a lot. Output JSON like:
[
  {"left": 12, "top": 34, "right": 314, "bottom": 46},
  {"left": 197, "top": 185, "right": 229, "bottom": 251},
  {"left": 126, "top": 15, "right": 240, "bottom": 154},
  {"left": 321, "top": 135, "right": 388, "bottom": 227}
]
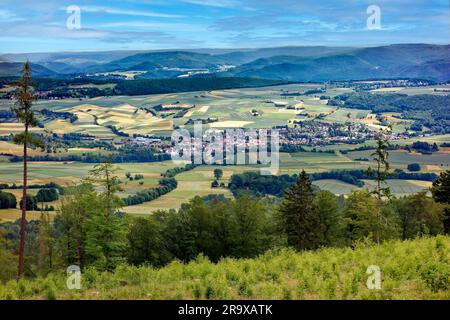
[{"left": 0, "top": 236, "right": 450, "bottom": 299}]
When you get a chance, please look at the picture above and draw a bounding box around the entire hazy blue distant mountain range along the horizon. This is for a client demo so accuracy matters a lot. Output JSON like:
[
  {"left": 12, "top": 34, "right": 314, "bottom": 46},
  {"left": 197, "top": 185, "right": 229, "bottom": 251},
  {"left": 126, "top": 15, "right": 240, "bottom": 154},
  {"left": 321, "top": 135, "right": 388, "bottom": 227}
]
[{"left": 0, "top": 44, "right": 450, "bottom": 82}]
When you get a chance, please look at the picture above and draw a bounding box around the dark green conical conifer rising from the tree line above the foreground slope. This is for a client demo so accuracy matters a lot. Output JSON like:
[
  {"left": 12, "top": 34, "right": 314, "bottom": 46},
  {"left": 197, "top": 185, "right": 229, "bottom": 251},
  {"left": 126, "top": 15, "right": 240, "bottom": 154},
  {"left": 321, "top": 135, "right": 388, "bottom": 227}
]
[{"left": 280, "top": 171, "right": 321, "bottom": 250}]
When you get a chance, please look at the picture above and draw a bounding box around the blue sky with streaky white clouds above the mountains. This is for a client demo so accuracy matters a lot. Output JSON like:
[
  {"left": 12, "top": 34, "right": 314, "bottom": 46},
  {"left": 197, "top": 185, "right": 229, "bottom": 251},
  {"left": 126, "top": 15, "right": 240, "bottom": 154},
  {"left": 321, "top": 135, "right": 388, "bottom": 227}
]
[{"left": 0, "top": 0, "right": 450, "bottom": 53}]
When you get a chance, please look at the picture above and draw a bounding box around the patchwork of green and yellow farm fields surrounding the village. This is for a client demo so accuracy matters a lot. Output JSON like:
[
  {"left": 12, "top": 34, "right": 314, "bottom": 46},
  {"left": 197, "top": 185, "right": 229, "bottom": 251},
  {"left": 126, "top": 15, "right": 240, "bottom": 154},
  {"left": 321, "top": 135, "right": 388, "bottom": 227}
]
[{"left": 0, "top": 83, "right": 450, "bottom": 220}]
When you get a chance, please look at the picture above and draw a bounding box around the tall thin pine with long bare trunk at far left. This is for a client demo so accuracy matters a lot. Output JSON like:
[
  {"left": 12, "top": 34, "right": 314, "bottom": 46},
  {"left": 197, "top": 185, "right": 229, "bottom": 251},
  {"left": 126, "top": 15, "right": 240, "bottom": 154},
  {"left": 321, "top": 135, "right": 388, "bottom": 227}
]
[{"left": 12, "top": 62, "right": 43, "bottom": 278}]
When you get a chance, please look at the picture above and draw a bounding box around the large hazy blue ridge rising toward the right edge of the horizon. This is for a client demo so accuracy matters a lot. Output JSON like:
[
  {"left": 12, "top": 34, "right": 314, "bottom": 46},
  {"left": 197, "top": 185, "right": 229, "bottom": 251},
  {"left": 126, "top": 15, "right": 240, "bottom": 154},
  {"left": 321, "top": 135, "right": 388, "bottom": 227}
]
[{"left": 227, "top": 44, "right": 450, "bottom": 81}]
